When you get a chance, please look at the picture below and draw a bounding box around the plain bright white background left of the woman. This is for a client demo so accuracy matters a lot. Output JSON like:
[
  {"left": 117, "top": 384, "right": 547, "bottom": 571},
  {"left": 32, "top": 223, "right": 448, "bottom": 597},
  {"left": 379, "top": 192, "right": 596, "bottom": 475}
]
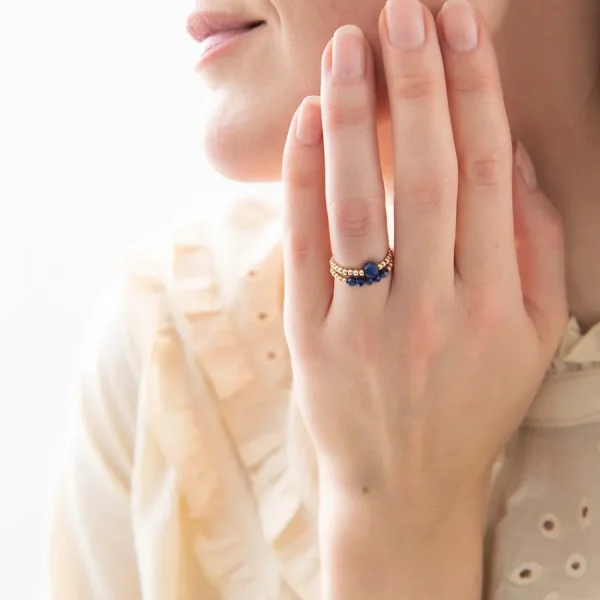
[{"left": 0, "top": 0, "right": 272, "bottom": 600}]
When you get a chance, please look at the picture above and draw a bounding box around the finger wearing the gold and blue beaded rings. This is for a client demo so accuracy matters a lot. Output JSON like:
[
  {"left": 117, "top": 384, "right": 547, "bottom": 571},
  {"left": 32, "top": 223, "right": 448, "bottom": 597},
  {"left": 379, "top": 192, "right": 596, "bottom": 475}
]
[{"left": 321, "top": 25, "right": 390, "bottom": 308}]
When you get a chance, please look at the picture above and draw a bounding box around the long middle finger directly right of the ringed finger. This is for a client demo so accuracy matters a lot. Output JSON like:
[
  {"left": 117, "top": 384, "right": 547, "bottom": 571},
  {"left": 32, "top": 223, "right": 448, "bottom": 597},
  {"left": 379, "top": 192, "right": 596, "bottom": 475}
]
[{"left": 379, "top": 0, "right": 458, "bottom": 295}]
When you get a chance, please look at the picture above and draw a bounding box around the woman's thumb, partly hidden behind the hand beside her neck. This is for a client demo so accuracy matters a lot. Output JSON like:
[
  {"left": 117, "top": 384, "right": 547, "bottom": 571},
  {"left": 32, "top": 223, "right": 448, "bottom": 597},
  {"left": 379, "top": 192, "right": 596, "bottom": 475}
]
[{"left": 513, "top": 142, "right": 569, "bottom": 349}]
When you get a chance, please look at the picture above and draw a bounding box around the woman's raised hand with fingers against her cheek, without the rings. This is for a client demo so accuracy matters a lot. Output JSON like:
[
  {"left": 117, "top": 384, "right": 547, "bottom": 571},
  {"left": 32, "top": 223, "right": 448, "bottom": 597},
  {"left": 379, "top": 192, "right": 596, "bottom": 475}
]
[{"left": 283, "top": 0, "right": 568, "bottom": 520}]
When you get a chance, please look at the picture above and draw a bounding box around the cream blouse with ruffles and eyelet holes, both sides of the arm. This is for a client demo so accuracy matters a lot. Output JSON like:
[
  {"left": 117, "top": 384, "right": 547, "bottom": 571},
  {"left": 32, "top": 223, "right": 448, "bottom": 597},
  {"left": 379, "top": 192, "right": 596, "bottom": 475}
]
[{"left": 47, "top": 196, "right": 600, "bottom": 600}]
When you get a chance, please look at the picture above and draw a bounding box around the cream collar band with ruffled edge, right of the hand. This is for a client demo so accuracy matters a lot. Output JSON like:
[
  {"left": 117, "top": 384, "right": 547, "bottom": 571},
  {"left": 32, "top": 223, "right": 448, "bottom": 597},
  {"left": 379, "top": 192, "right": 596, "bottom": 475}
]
[{"left": 524, "top": 317, "right": 600, "bottom": 427}]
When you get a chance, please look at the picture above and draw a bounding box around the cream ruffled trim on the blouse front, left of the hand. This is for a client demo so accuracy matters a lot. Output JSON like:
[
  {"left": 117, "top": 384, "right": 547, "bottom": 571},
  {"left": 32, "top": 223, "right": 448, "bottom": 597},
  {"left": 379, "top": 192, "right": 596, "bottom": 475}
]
[{"left": 142, "top": 201, "right": 320, "bottom": 600}]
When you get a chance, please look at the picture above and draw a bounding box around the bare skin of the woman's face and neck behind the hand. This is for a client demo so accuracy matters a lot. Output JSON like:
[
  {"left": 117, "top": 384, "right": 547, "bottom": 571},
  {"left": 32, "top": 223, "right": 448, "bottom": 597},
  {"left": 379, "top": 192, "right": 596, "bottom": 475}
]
[{"left": 193, "top": 0, "right": 600, "bottom": 332}]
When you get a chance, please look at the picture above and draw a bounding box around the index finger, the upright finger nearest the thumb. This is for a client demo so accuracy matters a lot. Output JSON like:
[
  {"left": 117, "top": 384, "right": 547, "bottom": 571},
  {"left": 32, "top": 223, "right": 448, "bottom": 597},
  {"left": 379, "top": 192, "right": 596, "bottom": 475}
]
[{"left": 438, "top": 0, "right": 520, "bottom": 290}]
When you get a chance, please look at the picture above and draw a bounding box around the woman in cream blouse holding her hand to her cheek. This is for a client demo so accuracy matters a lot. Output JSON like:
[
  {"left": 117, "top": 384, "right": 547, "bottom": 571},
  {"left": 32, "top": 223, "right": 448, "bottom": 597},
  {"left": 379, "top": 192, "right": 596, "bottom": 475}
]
[{"left": 50, "top": 0, "right": 600, "bottom": 600}]
